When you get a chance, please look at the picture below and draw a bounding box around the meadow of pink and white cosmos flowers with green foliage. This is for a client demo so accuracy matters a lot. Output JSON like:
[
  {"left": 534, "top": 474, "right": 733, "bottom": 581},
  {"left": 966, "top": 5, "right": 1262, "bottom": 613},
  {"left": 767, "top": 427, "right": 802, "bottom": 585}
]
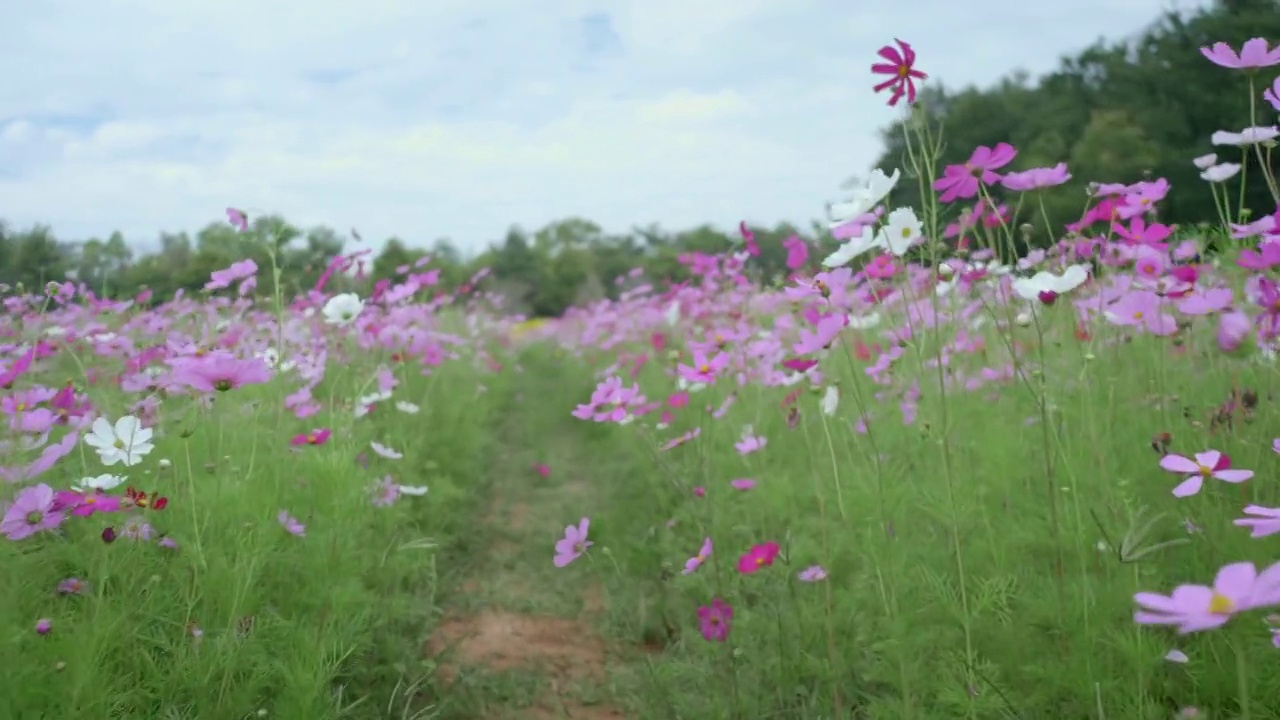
[{"left": 0, "top": 30, "right": 1280, "bottom": 720}]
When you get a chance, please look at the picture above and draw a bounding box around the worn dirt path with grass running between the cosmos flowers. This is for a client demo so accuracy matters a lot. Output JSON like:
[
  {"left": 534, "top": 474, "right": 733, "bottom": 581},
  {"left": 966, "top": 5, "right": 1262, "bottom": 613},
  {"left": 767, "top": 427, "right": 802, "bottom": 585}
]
[{"left": 426, "top": 389, "right": 626, "bottom": 720}]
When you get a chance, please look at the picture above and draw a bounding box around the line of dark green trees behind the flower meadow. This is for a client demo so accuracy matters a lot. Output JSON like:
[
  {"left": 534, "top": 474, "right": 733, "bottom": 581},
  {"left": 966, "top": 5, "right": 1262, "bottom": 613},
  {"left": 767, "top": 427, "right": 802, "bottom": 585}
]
[{"left": 0, "top": 0, "right": 1280, "bottom": 315}]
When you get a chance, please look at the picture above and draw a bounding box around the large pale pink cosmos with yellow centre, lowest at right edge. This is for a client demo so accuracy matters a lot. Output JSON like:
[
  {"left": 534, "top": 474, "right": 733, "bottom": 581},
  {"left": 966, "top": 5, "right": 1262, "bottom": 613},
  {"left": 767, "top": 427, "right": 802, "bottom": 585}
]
[{"left": 1133, "top": 562, "right": 1280, "bottom": 634}]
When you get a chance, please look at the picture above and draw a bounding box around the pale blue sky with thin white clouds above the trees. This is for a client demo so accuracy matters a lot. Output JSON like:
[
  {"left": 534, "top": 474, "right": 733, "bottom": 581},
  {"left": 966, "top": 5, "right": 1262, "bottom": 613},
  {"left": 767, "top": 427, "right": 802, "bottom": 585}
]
[{"left": 0, "top": 0, "right": 1199, "bottom": 252}]
